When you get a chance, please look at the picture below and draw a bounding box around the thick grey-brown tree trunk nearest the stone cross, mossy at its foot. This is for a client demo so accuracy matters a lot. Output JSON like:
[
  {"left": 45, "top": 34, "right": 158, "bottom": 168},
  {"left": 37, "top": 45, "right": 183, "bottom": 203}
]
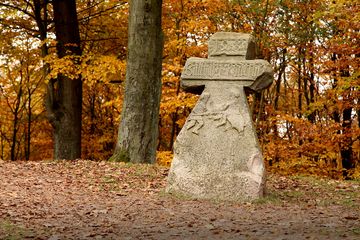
[{"left": 110, "top": 0, "right": 163, "bottom": 163}]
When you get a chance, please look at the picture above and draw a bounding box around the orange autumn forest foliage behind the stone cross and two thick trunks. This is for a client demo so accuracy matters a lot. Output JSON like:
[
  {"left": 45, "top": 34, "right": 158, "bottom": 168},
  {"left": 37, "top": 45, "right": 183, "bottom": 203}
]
[{"left": 0, "top": 0, "right": 360, "bottom": 178}]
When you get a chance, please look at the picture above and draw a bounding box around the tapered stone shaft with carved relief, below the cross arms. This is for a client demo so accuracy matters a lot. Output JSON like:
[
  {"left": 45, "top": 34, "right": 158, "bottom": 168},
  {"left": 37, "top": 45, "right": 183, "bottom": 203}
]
[{"left": 166, "top": 83, "right": 265, "bottom": 201}]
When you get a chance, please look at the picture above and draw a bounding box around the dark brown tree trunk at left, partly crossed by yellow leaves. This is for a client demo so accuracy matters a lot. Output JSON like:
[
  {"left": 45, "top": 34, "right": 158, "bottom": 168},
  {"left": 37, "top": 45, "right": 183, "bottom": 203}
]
[{"left": 46, "top": 0, "right": 82, "bottom": 159}]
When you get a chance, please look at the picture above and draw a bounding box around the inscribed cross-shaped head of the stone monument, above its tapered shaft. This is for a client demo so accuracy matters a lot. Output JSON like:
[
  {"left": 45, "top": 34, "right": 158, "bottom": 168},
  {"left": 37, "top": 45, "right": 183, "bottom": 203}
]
[{"left": 181, "top": 32, "right": 273, "bottom": 94}]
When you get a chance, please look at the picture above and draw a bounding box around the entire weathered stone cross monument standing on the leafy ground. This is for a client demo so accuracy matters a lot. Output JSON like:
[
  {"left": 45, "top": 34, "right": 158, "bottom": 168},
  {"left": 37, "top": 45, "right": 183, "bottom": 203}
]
[{"left": 166, "top": 32, "right": 273, "bottom": 201}]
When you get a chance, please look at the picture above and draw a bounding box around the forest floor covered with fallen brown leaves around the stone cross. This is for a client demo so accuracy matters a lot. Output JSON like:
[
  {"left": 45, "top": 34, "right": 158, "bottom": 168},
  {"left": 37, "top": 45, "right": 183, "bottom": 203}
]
[{"left": 0, "top": 160, "right": 360, "bottom": 240}]
